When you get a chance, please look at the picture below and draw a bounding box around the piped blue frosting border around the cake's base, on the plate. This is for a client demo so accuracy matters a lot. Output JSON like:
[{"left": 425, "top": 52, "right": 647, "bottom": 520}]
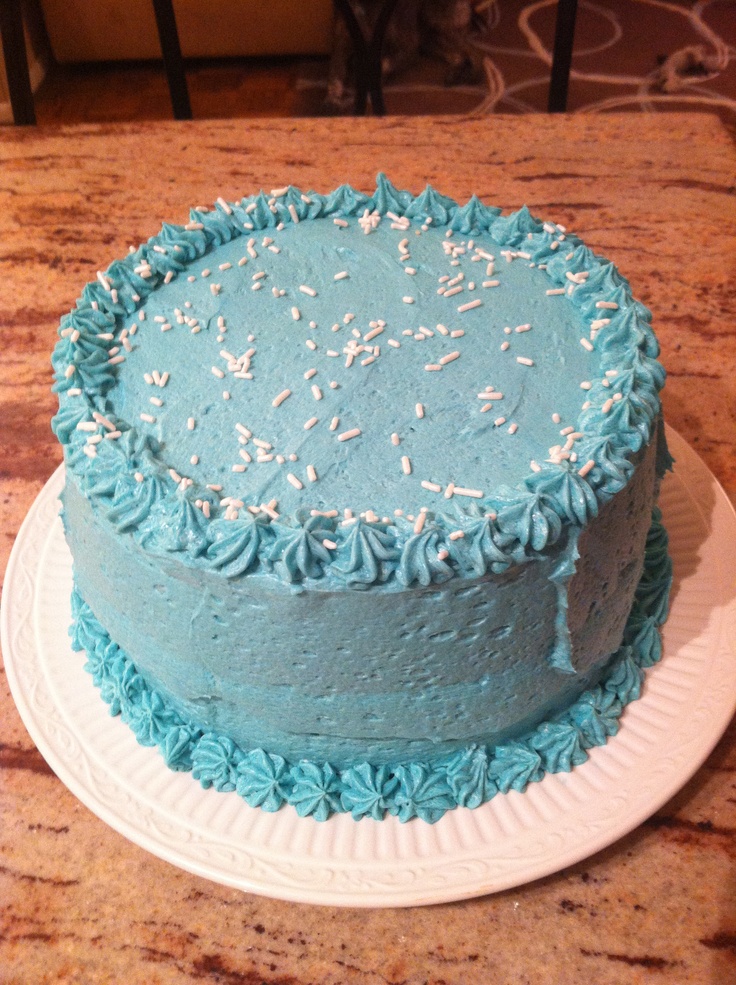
[{"left": 72, "top": 510, "right": 672, "bottom": 823}]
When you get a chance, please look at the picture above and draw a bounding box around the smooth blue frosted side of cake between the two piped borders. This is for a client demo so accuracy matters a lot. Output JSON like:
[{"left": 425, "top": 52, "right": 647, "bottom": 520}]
[{"left": 63, "top": 432, "right": 655, "bottom": 767}]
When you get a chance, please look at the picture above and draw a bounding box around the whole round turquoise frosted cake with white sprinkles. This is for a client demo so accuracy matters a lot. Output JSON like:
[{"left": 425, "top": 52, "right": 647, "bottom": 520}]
[{"left": 53, "top": 175, "right": 670, "bottom": 822}]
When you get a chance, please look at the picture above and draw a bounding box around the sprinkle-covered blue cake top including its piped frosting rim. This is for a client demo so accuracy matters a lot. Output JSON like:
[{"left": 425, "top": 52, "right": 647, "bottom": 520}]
[{"left": 49, "top": 176, "right": 663, "bottom": 583}]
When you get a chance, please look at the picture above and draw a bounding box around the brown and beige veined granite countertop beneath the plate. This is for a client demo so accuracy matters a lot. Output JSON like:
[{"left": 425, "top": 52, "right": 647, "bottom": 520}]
[{"left": 0, "top": 114, "right": 736, "bottom": 985}]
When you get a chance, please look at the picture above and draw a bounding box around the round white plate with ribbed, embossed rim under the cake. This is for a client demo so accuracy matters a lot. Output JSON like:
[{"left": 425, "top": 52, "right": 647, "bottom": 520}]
[{"left": 2, "top": 431, "right": 736, "bottom": 906}]
